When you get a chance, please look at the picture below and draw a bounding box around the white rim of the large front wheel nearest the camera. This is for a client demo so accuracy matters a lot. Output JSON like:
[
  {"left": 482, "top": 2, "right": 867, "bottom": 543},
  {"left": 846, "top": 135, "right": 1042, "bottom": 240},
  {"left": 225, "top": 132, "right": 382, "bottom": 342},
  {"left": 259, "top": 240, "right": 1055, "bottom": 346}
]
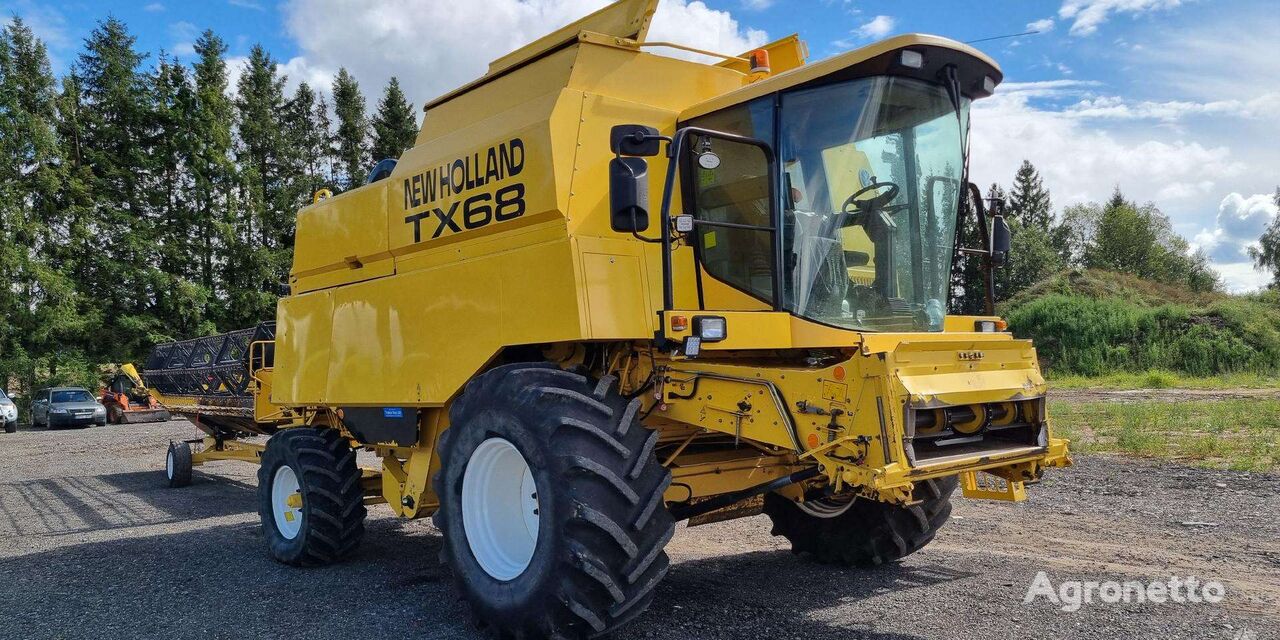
[{"left": 462, "top": 438, "right": 539, "bottom": 581}]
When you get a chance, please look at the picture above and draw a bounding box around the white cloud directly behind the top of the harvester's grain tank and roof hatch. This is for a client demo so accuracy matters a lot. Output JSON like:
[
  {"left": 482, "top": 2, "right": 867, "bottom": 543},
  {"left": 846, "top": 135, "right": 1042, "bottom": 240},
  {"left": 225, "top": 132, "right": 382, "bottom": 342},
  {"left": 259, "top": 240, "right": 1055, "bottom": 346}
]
[{"left": 282, "top": 0, "right": 768, "bottom": 105}]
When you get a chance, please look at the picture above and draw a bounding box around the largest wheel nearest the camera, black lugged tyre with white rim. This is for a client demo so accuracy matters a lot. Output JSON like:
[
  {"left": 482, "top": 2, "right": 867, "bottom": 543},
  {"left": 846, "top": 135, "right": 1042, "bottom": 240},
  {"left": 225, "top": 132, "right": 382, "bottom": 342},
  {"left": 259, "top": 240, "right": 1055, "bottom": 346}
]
[{"left": 433, "top": 364, "right": 675, "bottom": 637}]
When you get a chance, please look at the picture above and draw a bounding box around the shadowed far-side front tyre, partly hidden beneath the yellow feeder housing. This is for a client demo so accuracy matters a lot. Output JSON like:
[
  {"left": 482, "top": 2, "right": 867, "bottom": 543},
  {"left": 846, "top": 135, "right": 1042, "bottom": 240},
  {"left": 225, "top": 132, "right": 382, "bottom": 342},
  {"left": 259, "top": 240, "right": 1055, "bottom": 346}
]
[{"left": 764, "top": 477, "right": 957, "bottom": 567}]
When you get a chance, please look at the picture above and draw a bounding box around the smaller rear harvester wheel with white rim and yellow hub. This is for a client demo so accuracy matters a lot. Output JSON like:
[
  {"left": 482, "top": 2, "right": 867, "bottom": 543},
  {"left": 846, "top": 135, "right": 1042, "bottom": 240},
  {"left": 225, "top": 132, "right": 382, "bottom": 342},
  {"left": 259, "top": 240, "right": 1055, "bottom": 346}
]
[{"left": 257, "top": 428, "right": 366, "bottom": 567}]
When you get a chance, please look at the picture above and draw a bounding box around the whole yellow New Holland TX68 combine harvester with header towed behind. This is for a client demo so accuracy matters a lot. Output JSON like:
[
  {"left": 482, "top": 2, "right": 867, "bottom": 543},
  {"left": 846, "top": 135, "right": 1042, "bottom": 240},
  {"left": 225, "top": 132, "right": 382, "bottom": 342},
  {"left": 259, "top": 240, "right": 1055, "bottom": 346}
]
[{"left": 147, "top": 0, "right": 1069, "bottom": 637}]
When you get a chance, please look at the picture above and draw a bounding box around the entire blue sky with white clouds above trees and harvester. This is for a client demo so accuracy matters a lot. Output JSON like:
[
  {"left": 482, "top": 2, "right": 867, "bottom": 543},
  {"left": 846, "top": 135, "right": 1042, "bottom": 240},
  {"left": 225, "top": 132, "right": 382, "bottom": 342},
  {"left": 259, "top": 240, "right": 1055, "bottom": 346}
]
[{"left": 10, "top": 0, "right": 1280, "bottom": 291}]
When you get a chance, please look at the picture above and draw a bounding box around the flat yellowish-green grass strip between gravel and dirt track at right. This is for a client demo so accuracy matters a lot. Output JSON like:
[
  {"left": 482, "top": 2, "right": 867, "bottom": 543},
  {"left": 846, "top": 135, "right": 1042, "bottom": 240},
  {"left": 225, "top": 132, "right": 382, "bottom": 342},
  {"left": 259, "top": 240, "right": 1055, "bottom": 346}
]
[{"left": 1050, "top": 399, "right": 1280, "bottom": 471}]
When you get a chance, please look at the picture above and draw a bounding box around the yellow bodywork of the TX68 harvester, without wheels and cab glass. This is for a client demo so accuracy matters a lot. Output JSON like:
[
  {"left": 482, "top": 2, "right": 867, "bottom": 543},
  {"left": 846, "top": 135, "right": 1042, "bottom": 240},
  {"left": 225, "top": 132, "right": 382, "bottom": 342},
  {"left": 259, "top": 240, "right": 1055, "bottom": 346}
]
[{"left": 247, "top": 0, "right": 1069, "bottom": 517}]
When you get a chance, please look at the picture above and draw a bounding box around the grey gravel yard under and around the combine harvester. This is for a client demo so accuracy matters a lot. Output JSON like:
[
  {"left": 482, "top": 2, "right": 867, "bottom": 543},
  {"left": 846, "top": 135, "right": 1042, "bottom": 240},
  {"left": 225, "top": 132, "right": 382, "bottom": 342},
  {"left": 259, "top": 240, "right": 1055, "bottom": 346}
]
[{"left": 0, "top": 421, "right": 1280, "bottom": 640}]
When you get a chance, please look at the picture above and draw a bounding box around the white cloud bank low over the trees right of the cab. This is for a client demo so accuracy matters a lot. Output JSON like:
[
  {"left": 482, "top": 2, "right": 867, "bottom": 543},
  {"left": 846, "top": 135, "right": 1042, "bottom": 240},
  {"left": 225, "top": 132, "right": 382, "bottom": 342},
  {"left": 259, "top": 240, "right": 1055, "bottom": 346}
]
[{"left": 970, "top": 79, "right": 1276, "bottom": 291}]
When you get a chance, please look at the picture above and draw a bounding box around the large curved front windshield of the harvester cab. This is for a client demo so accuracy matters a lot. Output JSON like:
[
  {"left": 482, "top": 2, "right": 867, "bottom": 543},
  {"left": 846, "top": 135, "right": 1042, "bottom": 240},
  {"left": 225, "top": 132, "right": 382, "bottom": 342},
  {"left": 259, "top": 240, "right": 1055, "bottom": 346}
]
[{"left": 778, "top": 78, "right": 968, "bottom": 332}]
